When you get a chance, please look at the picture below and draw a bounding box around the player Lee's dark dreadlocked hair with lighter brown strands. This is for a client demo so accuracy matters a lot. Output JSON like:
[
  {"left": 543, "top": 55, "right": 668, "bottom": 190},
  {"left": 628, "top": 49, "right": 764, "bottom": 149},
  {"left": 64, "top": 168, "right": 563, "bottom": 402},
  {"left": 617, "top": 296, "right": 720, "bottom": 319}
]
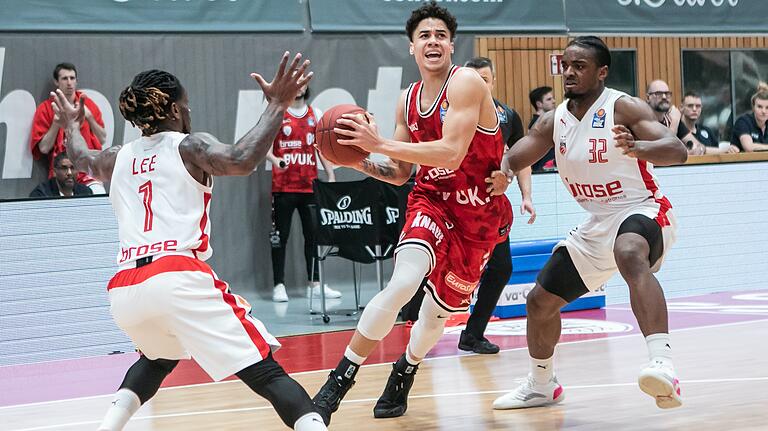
[{"left": 120, "top": 69, "right": 184, "bottom": 136}]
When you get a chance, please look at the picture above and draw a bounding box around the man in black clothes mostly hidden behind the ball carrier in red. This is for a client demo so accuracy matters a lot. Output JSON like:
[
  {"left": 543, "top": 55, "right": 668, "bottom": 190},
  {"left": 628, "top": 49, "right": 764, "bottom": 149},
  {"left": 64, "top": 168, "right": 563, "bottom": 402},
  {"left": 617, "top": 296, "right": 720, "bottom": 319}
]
[{"left": 459, "top": 57, "right": 536, "bottom": 354}]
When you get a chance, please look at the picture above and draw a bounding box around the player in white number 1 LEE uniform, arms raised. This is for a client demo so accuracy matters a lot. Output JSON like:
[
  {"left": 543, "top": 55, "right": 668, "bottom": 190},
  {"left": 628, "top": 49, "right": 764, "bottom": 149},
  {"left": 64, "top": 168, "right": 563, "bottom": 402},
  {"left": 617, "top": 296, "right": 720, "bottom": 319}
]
[{"left": 54, "top": 52, "right": 326, "bottom": 431}]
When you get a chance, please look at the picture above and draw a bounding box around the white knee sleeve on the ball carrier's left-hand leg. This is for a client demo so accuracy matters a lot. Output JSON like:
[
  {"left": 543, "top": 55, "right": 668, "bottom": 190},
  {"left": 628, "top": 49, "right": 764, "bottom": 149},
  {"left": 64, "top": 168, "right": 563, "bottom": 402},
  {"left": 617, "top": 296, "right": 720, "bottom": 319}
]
[{"left": 357, "top": 248, "right": 429, "bottom": 341}]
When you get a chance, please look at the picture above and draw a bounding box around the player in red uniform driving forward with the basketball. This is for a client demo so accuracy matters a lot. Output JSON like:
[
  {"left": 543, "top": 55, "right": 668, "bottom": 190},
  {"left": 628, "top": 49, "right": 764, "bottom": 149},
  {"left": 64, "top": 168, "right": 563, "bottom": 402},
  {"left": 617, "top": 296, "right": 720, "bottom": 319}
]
[{"left": 313, "top": 1, "right": 511, "bottom": 421}]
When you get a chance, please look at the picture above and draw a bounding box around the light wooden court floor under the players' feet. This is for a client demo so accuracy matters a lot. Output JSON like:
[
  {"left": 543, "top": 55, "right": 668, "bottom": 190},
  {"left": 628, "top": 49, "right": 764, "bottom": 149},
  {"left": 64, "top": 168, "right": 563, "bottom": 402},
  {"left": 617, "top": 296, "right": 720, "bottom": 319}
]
[{"left": 0, "top": 320, "right": 768, "bottom": 431}]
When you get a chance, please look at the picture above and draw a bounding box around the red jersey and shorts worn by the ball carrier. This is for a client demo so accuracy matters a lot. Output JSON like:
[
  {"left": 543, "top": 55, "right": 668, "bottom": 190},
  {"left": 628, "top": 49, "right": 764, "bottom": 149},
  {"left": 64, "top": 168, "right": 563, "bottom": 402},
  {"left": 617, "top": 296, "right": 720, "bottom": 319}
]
[{"left": 396, "top": 66, "right": 511, "bottom": 312}]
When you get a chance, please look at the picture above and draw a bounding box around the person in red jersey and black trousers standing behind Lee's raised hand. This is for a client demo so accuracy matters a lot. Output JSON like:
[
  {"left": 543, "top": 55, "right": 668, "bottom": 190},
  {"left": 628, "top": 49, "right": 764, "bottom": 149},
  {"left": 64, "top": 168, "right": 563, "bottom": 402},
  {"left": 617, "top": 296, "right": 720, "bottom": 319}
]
[{"left": 267, "top": 86, "right": 341, "bottom": 302}]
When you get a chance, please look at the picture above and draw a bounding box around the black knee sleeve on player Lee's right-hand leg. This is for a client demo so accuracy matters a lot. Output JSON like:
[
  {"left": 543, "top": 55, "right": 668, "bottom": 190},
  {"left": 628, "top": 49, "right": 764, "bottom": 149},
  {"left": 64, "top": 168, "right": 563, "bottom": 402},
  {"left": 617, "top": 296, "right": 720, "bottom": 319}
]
[{"left": 235, "top": 353, "right": 316, "bottom": 428}]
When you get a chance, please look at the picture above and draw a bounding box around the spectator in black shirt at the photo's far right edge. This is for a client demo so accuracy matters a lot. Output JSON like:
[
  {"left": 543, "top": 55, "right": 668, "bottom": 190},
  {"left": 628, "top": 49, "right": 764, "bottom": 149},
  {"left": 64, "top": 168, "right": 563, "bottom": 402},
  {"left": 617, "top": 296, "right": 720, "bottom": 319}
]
[{"left": 731, "top": 82, "right": 768, "bottom": 153}]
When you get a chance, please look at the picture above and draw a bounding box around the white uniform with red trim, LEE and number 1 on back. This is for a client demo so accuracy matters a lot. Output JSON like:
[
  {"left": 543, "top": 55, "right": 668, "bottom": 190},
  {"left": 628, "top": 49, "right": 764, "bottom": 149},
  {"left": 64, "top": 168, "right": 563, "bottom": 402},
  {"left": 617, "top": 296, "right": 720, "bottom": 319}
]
[{"left": 108, "top": 132, "right": 280, "bottom": 380}]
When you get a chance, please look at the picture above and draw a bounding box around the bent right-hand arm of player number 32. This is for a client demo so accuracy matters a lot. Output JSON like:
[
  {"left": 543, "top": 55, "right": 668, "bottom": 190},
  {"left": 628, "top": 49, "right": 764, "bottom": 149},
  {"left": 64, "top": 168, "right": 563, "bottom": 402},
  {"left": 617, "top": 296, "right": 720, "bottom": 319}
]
[{"left": 613, "top": 97, "right": 688, "bottom": 166}]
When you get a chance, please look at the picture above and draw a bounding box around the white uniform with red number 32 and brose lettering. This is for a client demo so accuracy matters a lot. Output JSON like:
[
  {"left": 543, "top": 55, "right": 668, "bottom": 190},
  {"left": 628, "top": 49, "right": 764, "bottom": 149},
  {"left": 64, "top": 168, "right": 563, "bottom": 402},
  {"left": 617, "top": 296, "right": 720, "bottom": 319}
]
[{"left": 552, "top": 88, "right": 675, "bottom": 290}]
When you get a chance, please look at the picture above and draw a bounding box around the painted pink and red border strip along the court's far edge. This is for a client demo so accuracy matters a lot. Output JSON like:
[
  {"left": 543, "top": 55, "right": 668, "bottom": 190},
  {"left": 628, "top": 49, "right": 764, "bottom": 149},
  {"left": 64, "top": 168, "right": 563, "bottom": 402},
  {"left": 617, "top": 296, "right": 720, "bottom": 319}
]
[{"left": 0, "top": 291, "right": 768, "bottom": 408}]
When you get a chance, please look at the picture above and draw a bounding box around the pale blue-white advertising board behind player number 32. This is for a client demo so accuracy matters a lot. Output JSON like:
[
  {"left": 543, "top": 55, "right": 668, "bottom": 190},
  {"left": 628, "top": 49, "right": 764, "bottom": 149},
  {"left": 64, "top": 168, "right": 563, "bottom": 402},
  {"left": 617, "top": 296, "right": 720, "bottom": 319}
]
[{"left": 507, "top": 162, "right": 768, "bottom": 304}]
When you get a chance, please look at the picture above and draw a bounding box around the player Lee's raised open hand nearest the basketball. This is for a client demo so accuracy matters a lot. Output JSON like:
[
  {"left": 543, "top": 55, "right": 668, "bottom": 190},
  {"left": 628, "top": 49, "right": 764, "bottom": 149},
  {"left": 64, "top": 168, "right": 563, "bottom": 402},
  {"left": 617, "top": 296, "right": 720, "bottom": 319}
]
[{"left": 251, "top": 51, "right": 313, "bottom": 108}]
